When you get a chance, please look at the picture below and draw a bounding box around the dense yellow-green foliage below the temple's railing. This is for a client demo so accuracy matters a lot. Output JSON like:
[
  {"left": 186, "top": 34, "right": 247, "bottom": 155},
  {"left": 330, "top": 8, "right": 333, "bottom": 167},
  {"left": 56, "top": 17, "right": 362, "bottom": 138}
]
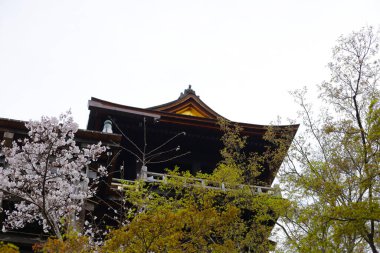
[{"left": 102, "top": 178, "right": 285, "bottom": 252}]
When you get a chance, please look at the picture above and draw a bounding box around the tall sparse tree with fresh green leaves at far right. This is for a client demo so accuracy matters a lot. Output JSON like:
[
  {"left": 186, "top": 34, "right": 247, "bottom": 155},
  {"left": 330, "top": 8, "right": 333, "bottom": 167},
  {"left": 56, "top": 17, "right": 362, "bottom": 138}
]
[{"left": 278, "top": 27, "right": 380, "bottom": 252}]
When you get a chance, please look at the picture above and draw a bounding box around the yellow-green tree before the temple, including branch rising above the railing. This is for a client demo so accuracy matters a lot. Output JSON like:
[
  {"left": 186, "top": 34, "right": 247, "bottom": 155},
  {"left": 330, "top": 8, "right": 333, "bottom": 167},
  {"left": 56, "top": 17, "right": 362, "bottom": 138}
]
[{"left": 101, "top": 121, "right": 288, "bottom": 252}]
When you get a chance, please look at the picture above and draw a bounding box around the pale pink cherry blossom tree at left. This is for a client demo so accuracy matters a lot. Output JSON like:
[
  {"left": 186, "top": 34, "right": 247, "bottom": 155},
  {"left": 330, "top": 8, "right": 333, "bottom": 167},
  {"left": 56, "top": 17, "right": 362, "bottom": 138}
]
[{"left": 0, "top": 112, "right": 107, "bottom": 238}]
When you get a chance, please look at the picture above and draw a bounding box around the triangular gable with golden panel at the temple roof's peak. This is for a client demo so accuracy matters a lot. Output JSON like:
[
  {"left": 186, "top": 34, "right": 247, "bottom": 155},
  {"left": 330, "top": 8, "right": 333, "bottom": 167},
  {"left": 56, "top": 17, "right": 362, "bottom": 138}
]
[{"left": 147, "top": 85, "right": 222, "bottom": 119}]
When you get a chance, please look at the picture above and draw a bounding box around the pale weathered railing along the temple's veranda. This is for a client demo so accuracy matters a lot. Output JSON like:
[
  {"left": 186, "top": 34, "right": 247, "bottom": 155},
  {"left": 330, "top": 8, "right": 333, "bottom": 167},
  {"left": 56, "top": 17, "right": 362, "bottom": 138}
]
[{"left": 111, "top": 171, "right": 281, "bottom": 196}]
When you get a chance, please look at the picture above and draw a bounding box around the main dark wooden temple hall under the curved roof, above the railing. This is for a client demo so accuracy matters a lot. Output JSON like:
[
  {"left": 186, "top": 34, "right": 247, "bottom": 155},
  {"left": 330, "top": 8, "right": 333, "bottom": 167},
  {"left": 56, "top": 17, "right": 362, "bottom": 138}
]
[{"left": 87, "top": 86, "right": 298, "bottom": 186}]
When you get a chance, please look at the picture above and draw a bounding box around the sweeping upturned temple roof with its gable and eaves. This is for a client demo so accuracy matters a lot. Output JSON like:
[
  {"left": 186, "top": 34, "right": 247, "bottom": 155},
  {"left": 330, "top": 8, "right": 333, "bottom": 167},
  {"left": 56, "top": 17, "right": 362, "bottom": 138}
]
[{"left": 87, "top": 86, "right": 299, "bottom": 135}]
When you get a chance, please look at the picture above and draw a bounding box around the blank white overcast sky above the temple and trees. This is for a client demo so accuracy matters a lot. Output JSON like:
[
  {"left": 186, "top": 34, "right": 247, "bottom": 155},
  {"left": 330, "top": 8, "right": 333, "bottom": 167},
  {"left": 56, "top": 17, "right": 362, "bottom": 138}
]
[{"left": 0, "top": 0, "right": 380, "bottom": 128}]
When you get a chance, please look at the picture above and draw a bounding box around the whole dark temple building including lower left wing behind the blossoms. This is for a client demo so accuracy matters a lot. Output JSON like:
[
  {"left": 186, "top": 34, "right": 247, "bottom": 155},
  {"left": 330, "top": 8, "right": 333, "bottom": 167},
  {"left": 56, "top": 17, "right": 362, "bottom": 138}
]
[{"left": 0, "top": 86, "right": 298, "bottom": 252}]
